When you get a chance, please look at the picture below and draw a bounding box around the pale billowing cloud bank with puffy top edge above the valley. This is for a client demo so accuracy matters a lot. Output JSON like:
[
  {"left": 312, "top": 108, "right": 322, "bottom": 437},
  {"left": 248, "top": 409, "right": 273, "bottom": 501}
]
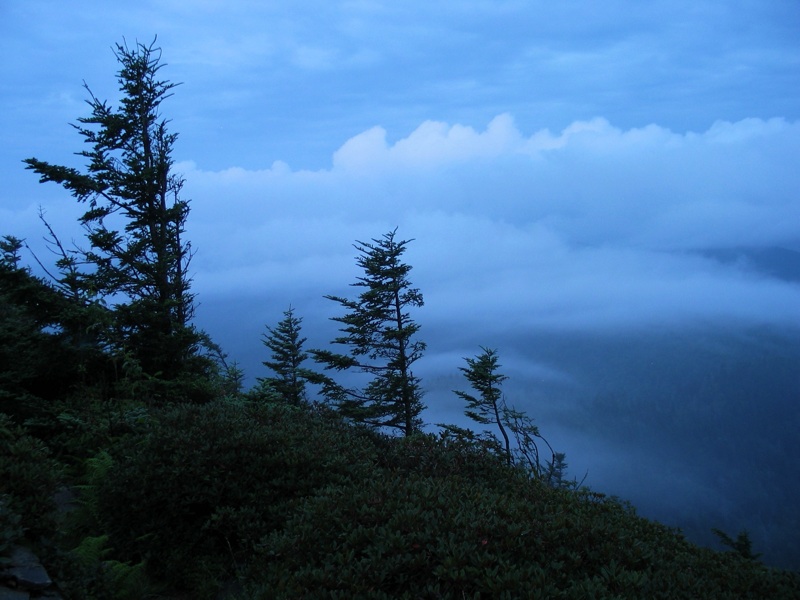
[{"left": 179, "top": 115, "right": 800, "bottom": 343}]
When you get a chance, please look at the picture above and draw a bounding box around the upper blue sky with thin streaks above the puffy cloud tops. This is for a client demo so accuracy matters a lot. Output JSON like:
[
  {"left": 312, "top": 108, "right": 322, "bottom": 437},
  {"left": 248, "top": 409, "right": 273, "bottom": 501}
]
[{"left": 0, "top": 0, "right": 800, "bottom": 169}]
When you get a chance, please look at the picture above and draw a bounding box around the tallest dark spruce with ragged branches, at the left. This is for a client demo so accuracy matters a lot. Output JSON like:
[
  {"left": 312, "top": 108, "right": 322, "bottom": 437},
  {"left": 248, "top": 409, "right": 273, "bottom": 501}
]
[{"left": 24, "top": 41, "right": 208, "bottom": 395}]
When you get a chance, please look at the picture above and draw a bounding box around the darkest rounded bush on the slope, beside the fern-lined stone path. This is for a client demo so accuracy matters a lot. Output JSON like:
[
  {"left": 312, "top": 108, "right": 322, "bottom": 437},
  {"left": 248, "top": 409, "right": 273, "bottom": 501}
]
[{"left": 98, "top": 402, "right": 376, "bottom": 593}]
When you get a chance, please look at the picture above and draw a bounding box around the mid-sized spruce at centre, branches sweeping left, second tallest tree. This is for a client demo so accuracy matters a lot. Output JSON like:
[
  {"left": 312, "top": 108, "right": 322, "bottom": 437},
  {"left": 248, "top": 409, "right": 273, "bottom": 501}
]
[{"left": 311, "top": 229, "right": 425, "bottom": 435}]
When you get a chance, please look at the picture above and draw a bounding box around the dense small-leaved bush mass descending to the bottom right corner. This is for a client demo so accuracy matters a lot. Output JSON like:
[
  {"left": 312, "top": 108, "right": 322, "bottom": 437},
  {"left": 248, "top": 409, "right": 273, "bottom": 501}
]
[{"left": 247, "top": 473, "right": 800, "bottom": 600}]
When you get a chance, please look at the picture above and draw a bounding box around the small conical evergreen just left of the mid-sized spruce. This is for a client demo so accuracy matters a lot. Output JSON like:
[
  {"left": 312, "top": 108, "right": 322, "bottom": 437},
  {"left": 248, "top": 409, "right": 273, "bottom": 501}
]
[{"left": 259, "top": 307, "right": 308, "bottom": 405}]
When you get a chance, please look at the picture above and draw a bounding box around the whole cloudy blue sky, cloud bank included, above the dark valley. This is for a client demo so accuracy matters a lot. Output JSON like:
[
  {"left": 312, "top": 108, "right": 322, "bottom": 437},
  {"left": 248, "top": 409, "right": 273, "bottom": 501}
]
[{"left": 0, "top": 0, "right": 800, "bottom": 560}]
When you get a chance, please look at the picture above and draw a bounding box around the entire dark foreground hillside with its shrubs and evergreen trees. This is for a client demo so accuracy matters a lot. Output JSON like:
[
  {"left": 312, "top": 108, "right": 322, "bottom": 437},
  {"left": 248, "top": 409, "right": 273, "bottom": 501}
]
[{"left": 0, "top": 39, "right": 800, "bottom": 600}]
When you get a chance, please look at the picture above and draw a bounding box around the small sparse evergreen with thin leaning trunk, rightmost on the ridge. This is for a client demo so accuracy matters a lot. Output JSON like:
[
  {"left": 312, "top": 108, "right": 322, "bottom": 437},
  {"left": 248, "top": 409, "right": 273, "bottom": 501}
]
[{"left": 455, "top": 347, "right": 512, "bottom": 465}]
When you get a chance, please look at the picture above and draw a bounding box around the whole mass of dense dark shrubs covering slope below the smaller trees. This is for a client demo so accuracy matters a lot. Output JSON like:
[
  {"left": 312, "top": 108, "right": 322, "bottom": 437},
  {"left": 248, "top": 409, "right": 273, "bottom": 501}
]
[{"left": 83, "top": 402, "right": 800, "bottom": 599}]
